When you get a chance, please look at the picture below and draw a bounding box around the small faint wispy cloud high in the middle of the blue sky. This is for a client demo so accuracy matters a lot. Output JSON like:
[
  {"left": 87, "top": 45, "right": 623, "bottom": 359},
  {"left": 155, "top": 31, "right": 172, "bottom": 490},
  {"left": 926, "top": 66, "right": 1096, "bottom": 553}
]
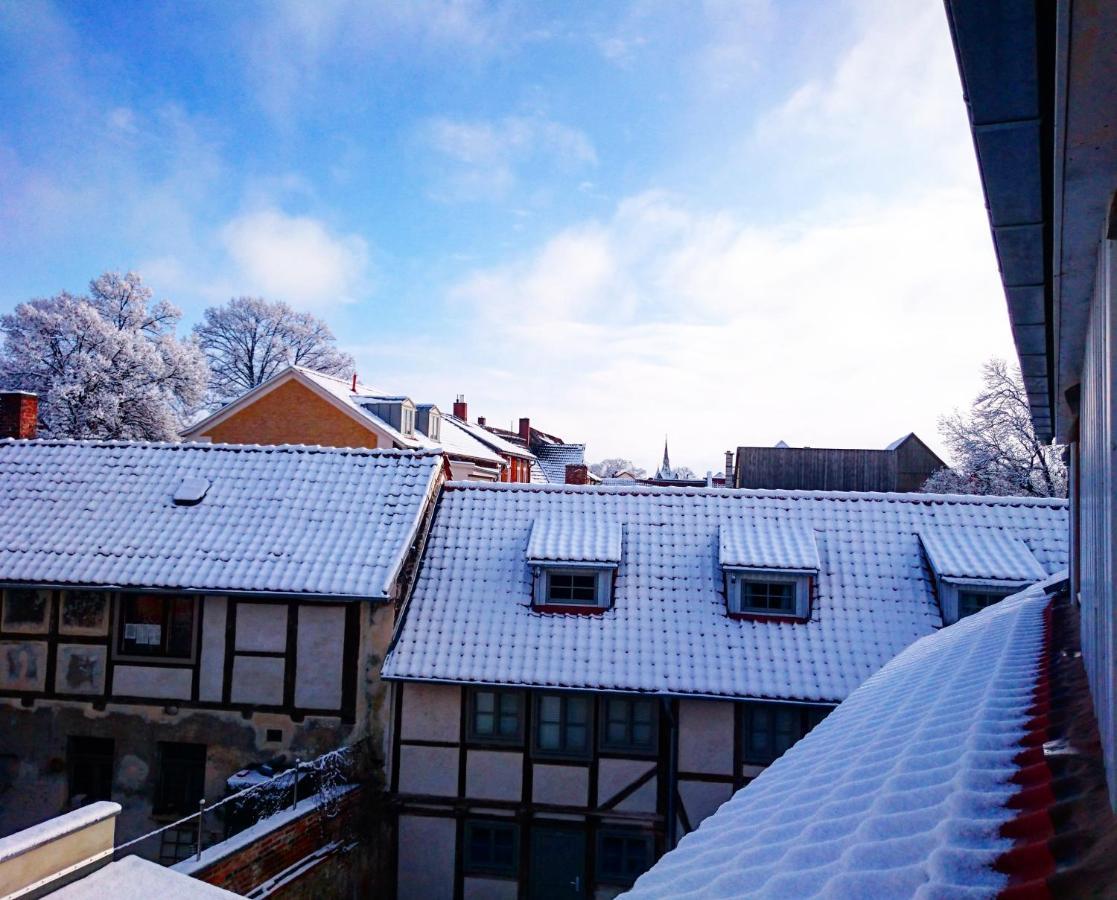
[{"left": 420, "top": 115, "right": 598, "bottom": 200}]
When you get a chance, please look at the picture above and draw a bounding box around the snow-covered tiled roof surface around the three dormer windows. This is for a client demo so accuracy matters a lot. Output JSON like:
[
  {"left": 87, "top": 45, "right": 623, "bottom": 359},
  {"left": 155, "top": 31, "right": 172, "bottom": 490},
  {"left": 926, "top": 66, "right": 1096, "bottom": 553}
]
[{"left": 383, "top": 482, "right": 1067, "bottom": 702}]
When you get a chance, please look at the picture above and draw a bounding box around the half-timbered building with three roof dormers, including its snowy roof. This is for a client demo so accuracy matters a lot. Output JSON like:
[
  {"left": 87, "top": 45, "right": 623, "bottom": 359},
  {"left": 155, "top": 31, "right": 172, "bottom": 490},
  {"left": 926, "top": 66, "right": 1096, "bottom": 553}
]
[{"left": 382, "top": 483, "right": 1067, "bottom": 898}]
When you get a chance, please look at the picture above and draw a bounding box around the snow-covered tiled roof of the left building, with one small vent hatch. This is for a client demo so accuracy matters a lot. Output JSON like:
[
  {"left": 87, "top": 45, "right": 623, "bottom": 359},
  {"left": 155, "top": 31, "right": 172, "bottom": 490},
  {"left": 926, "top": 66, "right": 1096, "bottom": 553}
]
[{"left": 0, "top": 440, "right": 442, "bottom": 599}]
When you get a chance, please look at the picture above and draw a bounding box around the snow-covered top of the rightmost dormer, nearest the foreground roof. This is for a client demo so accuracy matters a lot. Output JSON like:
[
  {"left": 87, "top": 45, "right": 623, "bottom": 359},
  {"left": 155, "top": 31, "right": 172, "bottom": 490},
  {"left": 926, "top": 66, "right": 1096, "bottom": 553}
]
[{"left": 919, "top": 525, "right": 1047, "bottom": 584}]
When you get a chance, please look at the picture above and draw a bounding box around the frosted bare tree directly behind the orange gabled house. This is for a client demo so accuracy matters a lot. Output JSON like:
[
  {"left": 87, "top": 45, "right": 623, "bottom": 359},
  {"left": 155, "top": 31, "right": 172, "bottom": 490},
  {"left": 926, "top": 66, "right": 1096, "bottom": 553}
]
[{"left": 194, "top": 297, "right": 354, "bottom": 405}]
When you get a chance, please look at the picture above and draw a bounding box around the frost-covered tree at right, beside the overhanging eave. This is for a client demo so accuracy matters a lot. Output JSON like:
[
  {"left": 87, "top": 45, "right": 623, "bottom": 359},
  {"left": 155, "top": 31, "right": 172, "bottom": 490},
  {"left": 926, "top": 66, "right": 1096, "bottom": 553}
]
[{"left": 923, "top": 360, "right": 1067, "bottom": 497}]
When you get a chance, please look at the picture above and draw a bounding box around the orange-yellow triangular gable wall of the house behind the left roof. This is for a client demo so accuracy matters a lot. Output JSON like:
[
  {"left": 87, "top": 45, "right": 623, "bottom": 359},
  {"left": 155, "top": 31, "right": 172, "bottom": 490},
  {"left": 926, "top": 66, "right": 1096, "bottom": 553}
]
[{"left": 198, "top": 381, "right": 391, "bottom": 448}]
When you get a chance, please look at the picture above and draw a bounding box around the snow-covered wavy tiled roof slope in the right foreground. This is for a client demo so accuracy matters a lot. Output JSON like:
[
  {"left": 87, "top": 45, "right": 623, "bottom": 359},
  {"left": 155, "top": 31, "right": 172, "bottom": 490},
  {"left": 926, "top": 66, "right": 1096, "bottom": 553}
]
[{"left": 626, "top": 580, "right": 1054, "bottom": 900}]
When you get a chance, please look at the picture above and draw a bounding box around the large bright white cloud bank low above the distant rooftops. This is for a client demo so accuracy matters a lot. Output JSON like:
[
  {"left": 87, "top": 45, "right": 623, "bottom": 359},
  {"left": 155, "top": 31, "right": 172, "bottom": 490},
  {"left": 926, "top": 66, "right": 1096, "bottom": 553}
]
[{"left": 404, "top": 190, "right": 1011, "bottom": 470}]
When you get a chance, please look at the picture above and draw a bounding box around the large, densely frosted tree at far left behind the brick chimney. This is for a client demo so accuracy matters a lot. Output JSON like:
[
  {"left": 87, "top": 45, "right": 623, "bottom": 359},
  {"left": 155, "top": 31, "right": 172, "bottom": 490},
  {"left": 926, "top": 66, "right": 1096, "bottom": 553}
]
[{"left": 0, "top": 272, "right": 208, "bottom": 440}]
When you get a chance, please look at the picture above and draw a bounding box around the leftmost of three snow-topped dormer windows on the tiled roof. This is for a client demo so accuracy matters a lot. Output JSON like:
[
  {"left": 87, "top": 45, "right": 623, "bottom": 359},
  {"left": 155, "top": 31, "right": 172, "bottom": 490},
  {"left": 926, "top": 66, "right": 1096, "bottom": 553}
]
[{"left": 527, "top": 516, "right": 621, "bottom": 612}]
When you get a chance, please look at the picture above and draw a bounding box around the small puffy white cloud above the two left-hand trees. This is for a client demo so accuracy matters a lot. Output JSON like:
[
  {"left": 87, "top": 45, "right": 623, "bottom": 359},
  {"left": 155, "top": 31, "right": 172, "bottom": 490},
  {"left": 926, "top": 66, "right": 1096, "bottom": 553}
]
[{"left": 220, "top": 209, "right": 370, "bottom": 308}]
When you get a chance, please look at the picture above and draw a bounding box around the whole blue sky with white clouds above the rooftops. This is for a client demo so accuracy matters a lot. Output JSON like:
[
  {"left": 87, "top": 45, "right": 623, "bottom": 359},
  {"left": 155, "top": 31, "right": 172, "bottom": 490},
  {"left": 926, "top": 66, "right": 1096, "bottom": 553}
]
[{"left": 0, "top": 0, "right": 1012, "bottom": 470}]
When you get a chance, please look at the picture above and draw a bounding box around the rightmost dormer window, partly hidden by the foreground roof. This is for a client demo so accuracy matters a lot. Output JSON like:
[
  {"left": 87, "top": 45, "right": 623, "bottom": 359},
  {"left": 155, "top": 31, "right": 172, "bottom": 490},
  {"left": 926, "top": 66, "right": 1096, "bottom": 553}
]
[{"left": 919, "top": 525, "right": 1048, "bottom": 625}]
